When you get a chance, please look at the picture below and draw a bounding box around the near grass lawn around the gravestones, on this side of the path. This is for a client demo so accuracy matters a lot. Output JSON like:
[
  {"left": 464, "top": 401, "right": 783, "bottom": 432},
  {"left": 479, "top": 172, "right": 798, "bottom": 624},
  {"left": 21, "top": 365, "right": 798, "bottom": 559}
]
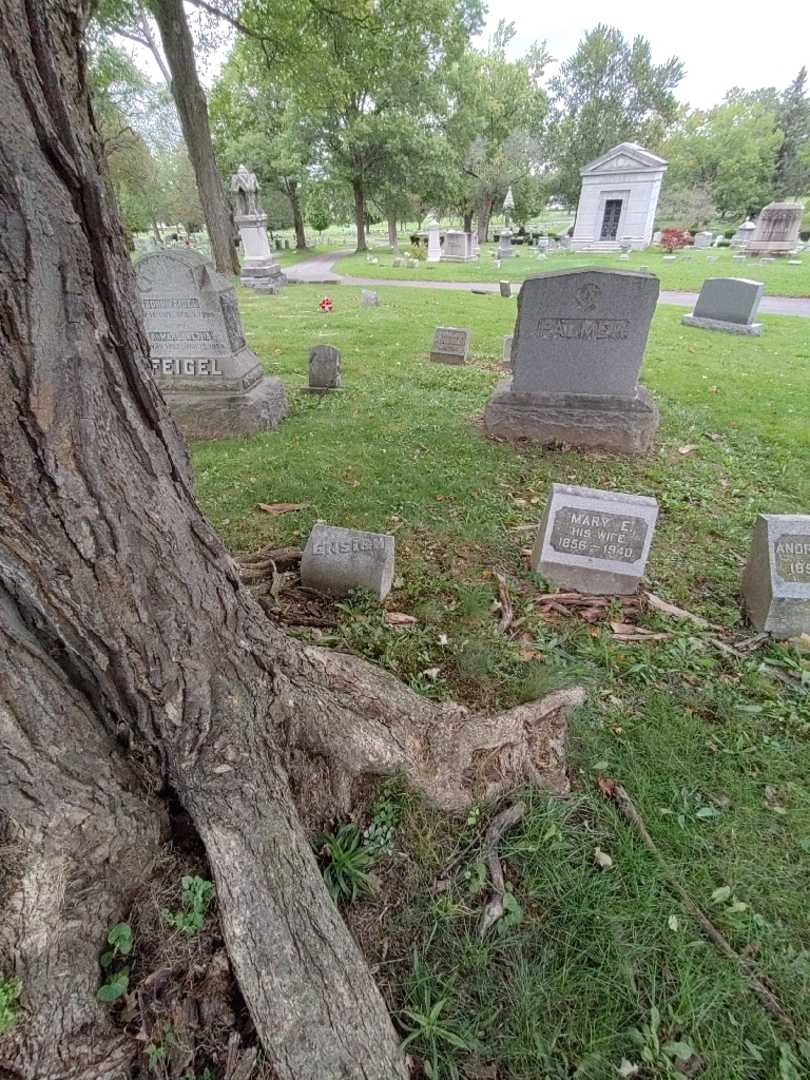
[{"left": 193, "top": 287, "right": 810, "bottom": 1080}]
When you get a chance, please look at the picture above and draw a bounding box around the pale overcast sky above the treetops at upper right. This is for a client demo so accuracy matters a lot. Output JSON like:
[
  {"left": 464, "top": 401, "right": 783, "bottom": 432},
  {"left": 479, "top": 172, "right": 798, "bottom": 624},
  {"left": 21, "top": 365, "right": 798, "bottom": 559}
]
[{"left": 482, "top": 0, "right": 810, "bottom": 108}]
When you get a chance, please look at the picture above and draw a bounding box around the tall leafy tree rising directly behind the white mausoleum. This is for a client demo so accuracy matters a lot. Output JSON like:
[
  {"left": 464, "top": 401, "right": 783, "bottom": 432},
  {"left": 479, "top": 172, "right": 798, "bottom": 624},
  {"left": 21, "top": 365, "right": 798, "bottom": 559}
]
[{"left": 549, "top": 24, "right": 684, "bottom": 206}]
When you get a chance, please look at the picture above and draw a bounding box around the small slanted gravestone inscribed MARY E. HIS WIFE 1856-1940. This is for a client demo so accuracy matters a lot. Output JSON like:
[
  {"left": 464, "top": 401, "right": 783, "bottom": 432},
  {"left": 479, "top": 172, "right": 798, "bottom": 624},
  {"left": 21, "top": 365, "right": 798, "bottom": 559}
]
[{"left": 531, "top": 484, "right": 658, "bottom": 594}]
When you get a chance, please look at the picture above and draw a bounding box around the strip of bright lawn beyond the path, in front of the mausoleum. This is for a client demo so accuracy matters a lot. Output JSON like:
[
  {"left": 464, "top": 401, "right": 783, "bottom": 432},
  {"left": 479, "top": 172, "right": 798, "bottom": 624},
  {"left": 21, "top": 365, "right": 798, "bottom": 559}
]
[{"left": 335, "top": 244, "right": 810, "bottom": 296}]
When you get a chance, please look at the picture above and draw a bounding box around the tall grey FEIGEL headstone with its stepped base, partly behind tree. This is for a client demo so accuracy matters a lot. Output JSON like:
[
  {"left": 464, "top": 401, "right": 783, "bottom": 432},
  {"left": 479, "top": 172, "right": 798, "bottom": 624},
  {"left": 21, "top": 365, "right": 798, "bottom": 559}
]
[{"left": 135, "top": 247, "right": 289, "bottom": 438}]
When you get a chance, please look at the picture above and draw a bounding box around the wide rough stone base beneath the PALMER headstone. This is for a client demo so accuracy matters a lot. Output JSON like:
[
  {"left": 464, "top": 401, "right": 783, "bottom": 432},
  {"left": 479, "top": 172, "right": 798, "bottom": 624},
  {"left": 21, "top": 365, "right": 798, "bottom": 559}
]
[{"left": 484, "top": 379, "right": 660, "bottom": 454}]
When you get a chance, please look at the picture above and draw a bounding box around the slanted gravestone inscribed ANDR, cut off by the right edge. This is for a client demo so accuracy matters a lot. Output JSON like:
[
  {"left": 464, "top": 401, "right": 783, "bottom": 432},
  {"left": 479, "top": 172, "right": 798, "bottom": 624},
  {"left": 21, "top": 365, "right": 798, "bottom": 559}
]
[{"left": 742, "top": 514, "right": 810, "bottom": 638}]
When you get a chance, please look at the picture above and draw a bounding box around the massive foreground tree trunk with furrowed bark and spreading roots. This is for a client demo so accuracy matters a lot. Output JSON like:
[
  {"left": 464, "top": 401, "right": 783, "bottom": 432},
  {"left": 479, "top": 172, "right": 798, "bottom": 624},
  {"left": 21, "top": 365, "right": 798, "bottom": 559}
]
[{"left": 0, "top": 0, "right": 581, "bottom": 1080}]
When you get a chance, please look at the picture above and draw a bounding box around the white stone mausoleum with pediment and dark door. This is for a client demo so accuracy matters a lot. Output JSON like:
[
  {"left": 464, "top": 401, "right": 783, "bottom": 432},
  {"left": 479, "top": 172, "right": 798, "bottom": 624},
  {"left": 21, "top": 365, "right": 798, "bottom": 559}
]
[{"left": 571, "top": 143, "right": 666, "bottom": 252}]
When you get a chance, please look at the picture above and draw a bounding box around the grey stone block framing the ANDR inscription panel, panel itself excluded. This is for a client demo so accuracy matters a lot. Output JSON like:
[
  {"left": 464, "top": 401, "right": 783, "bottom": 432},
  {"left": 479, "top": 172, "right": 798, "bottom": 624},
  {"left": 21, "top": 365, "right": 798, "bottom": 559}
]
[{"left": 742, "top": 514, "right": 810, "bottom": 639}]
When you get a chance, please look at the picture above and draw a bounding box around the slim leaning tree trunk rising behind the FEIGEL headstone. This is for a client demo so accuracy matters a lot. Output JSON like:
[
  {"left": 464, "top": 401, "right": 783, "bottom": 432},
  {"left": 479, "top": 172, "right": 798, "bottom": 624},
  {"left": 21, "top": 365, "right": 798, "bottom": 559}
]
[{"left": 151, "top": 0, "right": 239, "bottom": 274}]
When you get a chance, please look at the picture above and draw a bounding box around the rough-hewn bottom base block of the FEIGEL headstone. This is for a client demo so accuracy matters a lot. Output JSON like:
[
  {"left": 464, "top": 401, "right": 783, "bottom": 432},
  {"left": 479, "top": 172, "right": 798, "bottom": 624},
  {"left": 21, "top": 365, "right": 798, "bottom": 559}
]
[{"left": 163, "top": 376, "right": 289, "bottom": 440}]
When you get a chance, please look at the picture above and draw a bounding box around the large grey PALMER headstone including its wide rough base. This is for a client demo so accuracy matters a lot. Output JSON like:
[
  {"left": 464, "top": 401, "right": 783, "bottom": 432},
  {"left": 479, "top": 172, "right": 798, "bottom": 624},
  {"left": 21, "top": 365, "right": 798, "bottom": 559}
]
[{"left": 484, "top": 268, "right": 659, "bottom": 454}]
